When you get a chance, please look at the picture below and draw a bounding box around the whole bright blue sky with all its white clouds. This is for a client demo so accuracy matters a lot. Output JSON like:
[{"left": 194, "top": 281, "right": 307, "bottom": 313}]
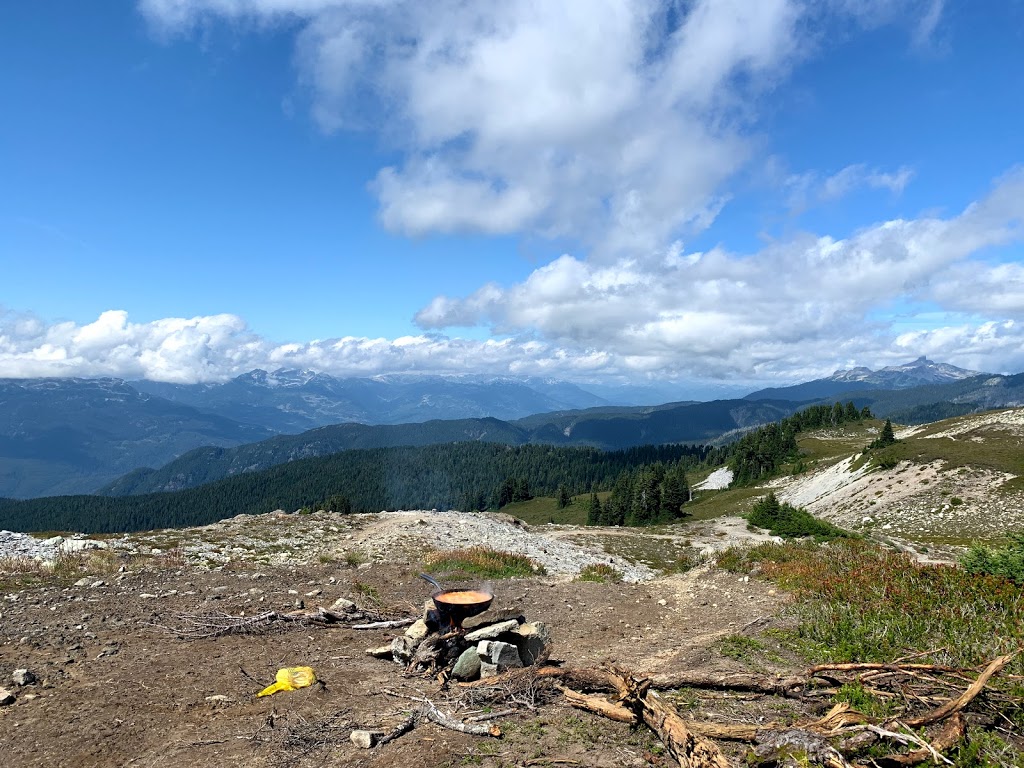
[{"left": 0, "top": 0, "right": 1024, "bottom": 392}]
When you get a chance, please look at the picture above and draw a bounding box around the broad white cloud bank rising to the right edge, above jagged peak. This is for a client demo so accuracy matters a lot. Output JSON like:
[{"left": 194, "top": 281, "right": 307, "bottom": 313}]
[{"left": 416, "top": 169, "right": 1024, "bottom": 376}]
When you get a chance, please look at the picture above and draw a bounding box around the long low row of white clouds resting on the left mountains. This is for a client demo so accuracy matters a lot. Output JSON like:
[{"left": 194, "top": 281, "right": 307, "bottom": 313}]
[{"left": 0, "top": 310, "right": 628, "bottom": 383}]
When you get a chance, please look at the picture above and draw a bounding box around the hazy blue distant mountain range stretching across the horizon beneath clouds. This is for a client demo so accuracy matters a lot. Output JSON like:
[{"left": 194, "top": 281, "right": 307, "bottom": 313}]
[{"left": 0, "top": 358, "right": 1024, "bottom": 498}]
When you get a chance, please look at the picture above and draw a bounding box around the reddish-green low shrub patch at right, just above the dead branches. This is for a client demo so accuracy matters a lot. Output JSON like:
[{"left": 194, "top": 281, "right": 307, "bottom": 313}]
[{"left": 719, "top": 540, "right": 1024, "bottom": 675}]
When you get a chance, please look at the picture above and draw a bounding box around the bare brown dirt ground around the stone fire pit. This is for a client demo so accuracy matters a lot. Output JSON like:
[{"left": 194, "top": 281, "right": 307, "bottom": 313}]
[{"left": 0, "top": 562, "right": 793, "bottom": 768}]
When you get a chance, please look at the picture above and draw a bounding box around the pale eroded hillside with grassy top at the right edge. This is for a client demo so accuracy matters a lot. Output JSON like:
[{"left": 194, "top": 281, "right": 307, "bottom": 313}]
[{"left": 771, "top": 409, "right": 1024, "bottom": 549}]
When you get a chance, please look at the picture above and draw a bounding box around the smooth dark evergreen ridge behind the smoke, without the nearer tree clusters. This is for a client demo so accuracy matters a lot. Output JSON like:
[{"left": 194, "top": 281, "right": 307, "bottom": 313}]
[{"left": 0, "top": 442, "right": 710, "bottom": 532}]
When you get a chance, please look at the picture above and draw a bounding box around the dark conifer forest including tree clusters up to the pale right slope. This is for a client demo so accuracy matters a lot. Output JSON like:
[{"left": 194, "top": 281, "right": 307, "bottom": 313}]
[{"left": 0, "top": 402, "right": 870, "bottom": 532}]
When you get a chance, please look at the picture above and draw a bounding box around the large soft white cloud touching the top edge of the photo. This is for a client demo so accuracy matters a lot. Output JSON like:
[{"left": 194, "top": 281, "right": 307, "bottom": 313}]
[{"left": 139, "top": 0, "right": 941, "bottom": 257}]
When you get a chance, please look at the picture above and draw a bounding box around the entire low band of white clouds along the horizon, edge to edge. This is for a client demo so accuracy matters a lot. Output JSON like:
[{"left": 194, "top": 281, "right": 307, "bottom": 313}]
[{"left": 0, "top": 169, "right": 1024, "bottom": 386}]
